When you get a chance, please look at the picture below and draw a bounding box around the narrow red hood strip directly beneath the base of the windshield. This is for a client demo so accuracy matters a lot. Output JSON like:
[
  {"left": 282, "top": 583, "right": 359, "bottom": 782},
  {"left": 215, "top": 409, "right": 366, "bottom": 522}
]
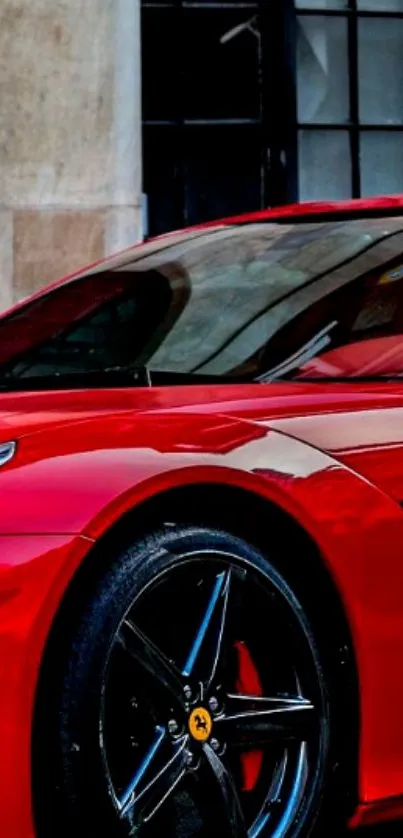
[{"left": 0, "top": 382, "right": 403, "bottom": 442}]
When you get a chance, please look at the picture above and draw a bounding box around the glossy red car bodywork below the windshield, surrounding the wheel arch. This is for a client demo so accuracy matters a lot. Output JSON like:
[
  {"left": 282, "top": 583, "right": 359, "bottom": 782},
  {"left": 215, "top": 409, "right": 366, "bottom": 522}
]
[{"left": 0, "top": 198, "right": 403, "bottom": 838}]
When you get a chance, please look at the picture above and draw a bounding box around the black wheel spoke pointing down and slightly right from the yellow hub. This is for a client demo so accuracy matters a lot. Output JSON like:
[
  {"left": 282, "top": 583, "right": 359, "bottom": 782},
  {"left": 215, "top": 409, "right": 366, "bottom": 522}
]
[{"left": 203, "top": 743, "right": 248, "bottom": 838}]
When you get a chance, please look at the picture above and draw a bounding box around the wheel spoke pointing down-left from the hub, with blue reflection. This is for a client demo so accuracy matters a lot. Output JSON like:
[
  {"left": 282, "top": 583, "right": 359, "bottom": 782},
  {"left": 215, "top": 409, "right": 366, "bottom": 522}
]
[{"left": 119, "top": 728, "right": 187, "bottom": 824}]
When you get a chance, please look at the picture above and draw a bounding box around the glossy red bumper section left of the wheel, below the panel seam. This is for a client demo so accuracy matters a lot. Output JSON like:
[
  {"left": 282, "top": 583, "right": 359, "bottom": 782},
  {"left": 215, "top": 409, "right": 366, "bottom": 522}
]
[{"left": 0, "top": 535, "right": 93, "bottom": 838}]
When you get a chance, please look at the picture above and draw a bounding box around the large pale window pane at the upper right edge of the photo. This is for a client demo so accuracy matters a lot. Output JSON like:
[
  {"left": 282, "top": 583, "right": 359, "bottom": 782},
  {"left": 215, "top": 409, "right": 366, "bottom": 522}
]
[{"left": 358, "top": 18, "right": 403, "bottom": 125}]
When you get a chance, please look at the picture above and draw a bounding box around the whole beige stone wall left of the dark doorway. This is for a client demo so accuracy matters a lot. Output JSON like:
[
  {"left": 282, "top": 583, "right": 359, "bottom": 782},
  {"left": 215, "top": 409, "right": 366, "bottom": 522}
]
[{"left": 0, "top": 0, "right": 141, "bottom": 308}]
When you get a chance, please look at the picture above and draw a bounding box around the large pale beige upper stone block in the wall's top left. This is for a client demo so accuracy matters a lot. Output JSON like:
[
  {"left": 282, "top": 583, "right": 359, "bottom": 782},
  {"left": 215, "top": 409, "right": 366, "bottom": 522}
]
[{"left": 0, "top": 0, "right": 116, "bottom": 207}]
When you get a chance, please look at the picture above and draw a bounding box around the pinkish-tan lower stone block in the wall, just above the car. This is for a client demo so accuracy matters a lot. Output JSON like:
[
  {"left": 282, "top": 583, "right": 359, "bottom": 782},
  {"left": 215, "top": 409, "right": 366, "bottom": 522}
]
[{"left": 13, "top": 210, "right": 105, "bottom": 300}]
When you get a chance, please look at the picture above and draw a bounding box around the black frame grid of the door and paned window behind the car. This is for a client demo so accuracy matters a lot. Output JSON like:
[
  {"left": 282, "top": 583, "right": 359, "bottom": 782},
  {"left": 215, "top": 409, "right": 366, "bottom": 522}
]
[{"left": 141, "top": 0, "right": 403, "bottom": 235}]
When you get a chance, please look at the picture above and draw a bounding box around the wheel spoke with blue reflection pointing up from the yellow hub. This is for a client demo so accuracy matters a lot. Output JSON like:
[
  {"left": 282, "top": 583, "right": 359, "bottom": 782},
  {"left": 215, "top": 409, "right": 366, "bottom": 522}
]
[{"left": 183, "top": 570, "right": 231, "bottom": 686}]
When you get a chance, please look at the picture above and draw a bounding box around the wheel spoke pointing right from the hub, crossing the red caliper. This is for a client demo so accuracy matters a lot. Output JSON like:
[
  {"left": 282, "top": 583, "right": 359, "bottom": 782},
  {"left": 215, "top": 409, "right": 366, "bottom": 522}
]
[{"left": 216, "top": 695, "right": 316, "bottom": 747}]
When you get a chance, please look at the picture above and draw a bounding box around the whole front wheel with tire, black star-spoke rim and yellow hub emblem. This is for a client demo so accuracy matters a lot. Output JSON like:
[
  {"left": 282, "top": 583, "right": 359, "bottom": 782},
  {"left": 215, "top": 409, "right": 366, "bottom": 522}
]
[{"left": 33, "top": 525, "right": 346, "bottom": 838}]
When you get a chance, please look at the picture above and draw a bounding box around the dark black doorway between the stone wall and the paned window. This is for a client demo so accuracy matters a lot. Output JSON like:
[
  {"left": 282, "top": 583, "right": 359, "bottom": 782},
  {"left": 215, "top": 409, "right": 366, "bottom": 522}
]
[{"left": 142, "top": 0, "right": 296, "bottom": 235}]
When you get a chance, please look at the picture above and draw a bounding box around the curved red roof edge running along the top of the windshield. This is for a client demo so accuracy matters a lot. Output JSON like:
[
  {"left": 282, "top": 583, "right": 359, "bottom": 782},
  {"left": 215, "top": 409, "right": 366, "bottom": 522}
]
[{"left": 0, "top": 194, "right": 403, "bottom": 320}]
